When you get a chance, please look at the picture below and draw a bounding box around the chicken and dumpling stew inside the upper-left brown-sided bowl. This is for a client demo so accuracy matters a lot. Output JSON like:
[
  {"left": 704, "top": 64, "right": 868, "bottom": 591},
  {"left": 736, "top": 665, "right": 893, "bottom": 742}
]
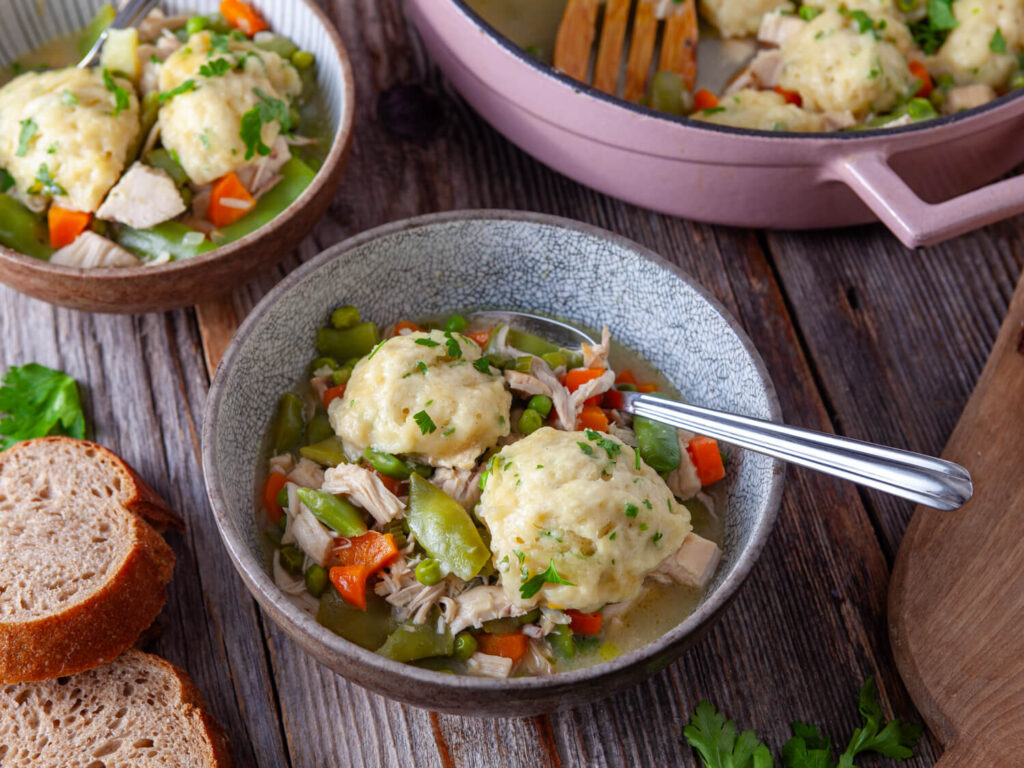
[{"left": 0, "top": 0, "right": 328, "bottom": 267}]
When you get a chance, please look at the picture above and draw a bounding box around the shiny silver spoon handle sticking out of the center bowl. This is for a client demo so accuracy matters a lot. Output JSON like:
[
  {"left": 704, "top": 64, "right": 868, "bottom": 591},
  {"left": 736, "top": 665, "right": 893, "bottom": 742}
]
[{"left": 623, "top": 392, "right": 974, "bottom": 510}]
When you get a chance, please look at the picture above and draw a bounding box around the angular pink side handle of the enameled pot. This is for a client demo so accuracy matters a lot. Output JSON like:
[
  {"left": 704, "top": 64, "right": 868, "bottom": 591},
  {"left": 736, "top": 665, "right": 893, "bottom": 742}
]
[{"left": 829, "top": 152, "right": 1024, "bottom": 248}]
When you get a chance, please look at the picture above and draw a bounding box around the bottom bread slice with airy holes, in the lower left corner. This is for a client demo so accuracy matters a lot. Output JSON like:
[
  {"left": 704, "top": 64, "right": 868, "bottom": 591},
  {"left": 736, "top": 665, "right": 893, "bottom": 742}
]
[{"left": 0, "top": 648, "right": 231, "bottom": 768}]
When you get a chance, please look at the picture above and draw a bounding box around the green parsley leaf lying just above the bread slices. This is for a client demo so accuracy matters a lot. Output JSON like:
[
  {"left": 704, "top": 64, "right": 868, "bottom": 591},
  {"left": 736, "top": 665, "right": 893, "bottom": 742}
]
[{"left": 0, "top": 362, "right": 85, "bottom": 451}]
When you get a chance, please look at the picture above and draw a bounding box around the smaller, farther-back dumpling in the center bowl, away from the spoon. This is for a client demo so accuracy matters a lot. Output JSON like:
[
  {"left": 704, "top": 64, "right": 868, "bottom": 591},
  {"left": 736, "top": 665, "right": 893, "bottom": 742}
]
[{"left": 328, "top": 331, "right": 512, "bottom": 469}]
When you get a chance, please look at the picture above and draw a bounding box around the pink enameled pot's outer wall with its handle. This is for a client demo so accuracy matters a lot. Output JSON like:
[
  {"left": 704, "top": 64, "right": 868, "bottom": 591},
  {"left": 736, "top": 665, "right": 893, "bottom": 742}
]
[{"left": 409, "top": 0, "right": 1024, "bottom": 247}]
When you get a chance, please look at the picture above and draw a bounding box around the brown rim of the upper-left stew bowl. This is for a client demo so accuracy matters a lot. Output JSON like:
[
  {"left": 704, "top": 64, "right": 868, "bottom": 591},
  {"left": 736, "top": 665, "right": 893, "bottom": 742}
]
[{"left": 0, "top": 0, "right": 355, "bottom": 283}]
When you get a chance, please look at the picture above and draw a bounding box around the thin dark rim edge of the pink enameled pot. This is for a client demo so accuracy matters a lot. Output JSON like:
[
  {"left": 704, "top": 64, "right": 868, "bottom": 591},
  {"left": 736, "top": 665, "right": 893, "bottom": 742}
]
[{"left": 451, "top": 0, "right": 1024, "bottom": 142}]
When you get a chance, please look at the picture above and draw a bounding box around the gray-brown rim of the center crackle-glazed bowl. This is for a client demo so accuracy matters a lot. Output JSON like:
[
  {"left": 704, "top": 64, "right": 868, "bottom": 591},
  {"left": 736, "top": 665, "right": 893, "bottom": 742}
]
[{"left": 202, "top": 209, "right": 784, "bottom": 693}]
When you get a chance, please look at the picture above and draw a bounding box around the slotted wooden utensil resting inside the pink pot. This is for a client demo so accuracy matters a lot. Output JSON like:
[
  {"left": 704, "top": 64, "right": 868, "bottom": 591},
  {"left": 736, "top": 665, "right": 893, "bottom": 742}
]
[{"left": 554, "top": 0, "right": 697, "bottom": 101}]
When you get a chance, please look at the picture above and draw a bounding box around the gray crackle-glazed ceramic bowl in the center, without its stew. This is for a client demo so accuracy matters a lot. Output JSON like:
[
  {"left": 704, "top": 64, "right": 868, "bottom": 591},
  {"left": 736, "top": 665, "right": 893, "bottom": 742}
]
[{"left": 203, "top": 211, "right": 782, "bottom": 716}]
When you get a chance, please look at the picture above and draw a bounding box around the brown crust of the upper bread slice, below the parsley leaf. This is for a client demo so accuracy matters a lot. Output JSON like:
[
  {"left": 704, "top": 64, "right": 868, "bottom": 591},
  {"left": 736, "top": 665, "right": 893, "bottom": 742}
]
[{"left": 0, "top": 437, "right": 181, "bottom": 683}]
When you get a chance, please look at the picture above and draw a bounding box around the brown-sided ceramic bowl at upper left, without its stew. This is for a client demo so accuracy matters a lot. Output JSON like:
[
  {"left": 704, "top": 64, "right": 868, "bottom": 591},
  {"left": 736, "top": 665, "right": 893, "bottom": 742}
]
[{"left": 0, "top": 0, "right": 355, "bottom": 312}]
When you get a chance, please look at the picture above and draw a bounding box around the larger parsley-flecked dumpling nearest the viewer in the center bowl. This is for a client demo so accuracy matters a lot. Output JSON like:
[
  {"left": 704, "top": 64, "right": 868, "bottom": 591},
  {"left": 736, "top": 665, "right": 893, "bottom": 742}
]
[{"left": 476, "top": 427, "right": 691, "bottom": 611}]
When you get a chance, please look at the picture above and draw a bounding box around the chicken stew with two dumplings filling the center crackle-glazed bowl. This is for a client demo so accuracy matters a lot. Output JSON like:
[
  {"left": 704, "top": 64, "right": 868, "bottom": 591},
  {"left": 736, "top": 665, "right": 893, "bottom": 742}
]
[{"left": 257, "top": 306, "right": 725, "bottom": 678}]
